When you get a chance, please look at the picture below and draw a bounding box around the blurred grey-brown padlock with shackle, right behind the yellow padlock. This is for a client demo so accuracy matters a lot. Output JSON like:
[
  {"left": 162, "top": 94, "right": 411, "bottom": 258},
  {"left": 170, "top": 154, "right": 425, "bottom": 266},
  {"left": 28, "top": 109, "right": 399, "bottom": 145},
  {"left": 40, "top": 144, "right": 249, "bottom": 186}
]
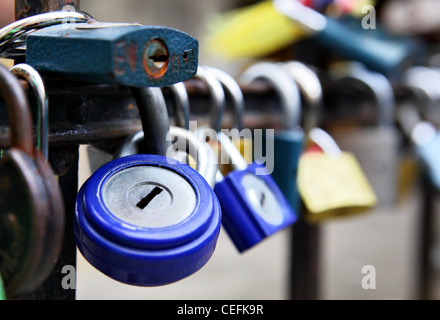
[{"left": 328, "top": 62, "right": 401, "bottom": 207}]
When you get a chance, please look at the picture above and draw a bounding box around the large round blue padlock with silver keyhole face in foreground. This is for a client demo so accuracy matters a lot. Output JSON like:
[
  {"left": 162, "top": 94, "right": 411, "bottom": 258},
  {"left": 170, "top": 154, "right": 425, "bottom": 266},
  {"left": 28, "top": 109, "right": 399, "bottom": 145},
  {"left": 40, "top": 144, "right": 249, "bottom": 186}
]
[{"left": 74, "top": 87, "right": 221, "bottom": 286}]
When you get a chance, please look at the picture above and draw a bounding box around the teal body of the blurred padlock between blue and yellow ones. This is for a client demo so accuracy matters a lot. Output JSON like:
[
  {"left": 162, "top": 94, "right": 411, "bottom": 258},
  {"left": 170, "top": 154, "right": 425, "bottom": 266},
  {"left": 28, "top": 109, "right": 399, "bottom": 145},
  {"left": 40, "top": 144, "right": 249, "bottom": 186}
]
[{"left": 263, "top": 130, "right": 304, "bottom": 213}]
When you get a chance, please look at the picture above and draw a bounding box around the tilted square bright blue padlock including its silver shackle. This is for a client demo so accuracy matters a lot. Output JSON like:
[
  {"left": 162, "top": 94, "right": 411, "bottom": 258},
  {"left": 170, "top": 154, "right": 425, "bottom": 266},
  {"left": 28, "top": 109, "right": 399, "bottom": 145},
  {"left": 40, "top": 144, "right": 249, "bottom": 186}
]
[{"left": 198, "top": 69, "right": 297, "bottom": 252}]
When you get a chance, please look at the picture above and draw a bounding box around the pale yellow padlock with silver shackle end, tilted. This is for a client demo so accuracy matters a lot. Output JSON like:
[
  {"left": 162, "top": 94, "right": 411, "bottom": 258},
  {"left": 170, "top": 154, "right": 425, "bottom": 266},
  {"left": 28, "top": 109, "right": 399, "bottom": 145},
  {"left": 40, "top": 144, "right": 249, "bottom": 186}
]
[{"left": 298, "top": 128, "right": 377, "bottom": 222}]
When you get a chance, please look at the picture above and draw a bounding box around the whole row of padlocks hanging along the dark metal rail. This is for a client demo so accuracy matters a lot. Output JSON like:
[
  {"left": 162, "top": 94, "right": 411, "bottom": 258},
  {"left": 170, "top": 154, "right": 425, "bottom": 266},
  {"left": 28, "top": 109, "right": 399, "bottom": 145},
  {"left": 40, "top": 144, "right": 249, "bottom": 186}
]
[{"left": 0, "top": 0, "right": 440, "bottom": 299}]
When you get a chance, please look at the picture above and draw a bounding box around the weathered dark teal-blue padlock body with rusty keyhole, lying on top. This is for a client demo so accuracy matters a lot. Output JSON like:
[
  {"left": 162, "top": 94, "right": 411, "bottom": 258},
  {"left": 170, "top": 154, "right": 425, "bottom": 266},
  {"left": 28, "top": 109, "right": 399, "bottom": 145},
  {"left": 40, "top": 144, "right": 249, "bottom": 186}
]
[{"left": 26, "top": 20, "right": 198, "bottom": 87}]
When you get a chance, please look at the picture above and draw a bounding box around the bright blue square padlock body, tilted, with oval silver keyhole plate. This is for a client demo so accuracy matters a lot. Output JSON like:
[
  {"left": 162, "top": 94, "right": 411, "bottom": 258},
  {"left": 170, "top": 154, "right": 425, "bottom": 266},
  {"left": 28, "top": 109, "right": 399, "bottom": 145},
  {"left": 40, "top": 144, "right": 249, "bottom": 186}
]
[{"left": 214, "top": 163, "right": 297, "bottom": 252}]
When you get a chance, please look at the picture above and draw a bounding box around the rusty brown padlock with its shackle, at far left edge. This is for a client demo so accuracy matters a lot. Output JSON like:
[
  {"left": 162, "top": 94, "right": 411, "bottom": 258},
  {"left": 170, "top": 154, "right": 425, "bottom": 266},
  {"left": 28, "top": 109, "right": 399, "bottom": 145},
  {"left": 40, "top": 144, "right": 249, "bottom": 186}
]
[{"left": 0, "top": 65, "right": 50, "bottom": 297}]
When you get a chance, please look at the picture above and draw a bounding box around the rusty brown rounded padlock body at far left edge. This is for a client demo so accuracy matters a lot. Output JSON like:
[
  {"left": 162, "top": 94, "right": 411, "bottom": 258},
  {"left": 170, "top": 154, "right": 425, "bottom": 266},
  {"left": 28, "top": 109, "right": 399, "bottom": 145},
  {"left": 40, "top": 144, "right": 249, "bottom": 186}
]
[{"left": 0, "top": 149, "right": 49, "bottom": 297}]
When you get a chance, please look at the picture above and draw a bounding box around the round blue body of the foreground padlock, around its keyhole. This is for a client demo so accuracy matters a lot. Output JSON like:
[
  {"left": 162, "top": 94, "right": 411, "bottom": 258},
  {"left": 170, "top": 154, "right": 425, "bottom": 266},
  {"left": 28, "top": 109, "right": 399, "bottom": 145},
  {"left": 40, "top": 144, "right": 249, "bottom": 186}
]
[{"left": 74, "top": 155, "right": 221, "bottom": 286}]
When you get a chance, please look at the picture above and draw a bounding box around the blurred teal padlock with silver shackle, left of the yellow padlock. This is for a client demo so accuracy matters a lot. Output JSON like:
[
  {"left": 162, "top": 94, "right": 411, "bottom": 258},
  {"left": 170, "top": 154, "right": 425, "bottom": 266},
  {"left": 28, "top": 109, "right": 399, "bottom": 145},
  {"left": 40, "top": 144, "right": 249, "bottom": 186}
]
[{"left": 239, "top": 62, "right": 304, "bottom": 212}]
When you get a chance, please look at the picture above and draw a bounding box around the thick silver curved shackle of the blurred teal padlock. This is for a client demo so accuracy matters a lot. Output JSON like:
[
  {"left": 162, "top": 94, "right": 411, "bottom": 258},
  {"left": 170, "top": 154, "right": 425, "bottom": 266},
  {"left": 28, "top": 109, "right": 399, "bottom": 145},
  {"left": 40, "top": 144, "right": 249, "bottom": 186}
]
[{"left": 238, "top": 62, "right": 301, "bottom": 130}]
